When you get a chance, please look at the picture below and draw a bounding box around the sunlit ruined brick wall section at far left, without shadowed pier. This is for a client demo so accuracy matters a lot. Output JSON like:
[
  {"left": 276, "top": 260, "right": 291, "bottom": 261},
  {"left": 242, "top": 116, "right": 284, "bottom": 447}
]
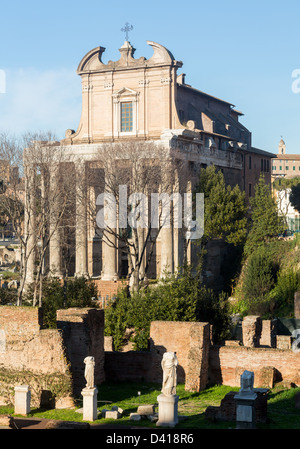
[{"left": 0, "top": 306, "right": 72, "bottom": 405}]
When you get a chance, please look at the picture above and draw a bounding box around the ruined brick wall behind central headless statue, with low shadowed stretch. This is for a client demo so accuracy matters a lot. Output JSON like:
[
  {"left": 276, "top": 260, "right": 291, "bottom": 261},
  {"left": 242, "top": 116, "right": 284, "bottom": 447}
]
[{"left": 105, "top": 321, "right": 210, "bottom": 391}]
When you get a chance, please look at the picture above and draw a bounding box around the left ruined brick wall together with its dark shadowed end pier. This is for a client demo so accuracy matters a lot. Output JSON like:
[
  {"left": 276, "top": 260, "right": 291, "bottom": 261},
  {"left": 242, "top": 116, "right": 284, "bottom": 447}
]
[{"left": 0, "top": 306, "right": 104, "bottom": 406}]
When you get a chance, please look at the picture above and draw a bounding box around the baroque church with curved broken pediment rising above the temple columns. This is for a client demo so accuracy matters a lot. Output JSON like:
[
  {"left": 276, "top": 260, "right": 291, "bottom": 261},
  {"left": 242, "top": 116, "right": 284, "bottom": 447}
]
[{"left": 24, "top": 40, "right": 274, "bottom": 294}]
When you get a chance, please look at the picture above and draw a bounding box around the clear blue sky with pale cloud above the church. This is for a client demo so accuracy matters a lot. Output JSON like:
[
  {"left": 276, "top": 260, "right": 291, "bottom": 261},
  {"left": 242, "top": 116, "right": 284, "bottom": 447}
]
[{"left": 0, "top": 0, "right": 300, "bottom": 154}]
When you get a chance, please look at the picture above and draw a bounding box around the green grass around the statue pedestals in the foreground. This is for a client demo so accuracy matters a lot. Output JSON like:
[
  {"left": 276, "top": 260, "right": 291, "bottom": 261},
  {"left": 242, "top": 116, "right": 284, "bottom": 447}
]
[{"left": 0, "top": 382, "right": 300, "bottom": 429}]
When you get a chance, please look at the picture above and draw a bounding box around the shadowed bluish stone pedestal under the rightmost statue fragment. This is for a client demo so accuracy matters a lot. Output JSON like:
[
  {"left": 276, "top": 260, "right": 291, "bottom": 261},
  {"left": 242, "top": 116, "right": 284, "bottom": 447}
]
[{"left": 234, "top": 393, "right": 257, "bottom": 429}]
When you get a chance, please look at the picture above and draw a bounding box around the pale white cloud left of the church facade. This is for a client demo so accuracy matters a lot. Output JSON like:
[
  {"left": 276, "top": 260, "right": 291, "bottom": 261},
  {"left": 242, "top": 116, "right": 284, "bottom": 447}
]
[{"left": 0, "top": 68, "right": 81, "bottom": 139}]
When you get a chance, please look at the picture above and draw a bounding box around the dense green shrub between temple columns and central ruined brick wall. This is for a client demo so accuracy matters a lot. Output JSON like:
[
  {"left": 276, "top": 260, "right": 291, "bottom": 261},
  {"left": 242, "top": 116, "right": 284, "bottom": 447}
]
[{"left": 105, "top": 268, "right": 229, "bottom": 350}]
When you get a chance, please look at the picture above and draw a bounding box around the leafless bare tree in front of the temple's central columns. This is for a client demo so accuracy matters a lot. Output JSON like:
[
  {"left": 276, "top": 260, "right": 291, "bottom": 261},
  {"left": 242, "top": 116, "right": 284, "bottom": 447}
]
[{"left": 90, "top": 140, "right": 186, "bottom": 290}]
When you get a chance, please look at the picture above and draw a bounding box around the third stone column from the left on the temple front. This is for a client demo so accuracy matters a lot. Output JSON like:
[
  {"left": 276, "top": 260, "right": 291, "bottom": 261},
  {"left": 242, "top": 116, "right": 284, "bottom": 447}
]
[{"left": 75, "top": 162, "right": 88, "bottom": 277}]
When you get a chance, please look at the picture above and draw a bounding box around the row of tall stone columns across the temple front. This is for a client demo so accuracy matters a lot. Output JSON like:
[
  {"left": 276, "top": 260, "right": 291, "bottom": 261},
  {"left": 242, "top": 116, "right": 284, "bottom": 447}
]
[{"left": 25, "top": 162, "right": 189, "bottom": 282}]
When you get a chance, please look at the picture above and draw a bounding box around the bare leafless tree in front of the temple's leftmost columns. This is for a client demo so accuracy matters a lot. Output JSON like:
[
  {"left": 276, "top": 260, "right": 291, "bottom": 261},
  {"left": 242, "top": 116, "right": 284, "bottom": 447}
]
[{"left": 24, "top": 135, "right": 74, "bottom": 305}]
